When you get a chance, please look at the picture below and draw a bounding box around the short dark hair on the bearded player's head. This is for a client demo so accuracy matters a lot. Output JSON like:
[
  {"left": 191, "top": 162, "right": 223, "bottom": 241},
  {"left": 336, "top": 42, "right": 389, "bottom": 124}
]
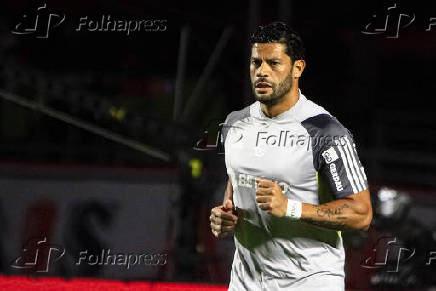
[{"left": 250, "top": 22, "right": 305, "bottom": 63}]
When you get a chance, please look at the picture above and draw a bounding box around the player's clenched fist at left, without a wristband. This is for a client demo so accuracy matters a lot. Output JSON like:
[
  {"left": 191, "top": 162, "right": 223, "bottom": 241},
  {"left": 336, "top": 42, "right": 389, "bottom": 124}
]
[{"left": 209, "top": 200, "right": 238, "bottom": 238}]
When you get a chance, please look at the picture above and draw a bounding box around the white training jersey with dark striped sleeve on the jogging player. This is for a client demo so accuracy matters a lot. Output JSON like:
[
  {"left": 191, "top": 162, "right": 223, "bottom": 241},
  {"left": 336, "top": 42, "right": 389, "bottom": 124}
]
[{"left": 221, "top": 91, "right": 368, "bottom": 291}]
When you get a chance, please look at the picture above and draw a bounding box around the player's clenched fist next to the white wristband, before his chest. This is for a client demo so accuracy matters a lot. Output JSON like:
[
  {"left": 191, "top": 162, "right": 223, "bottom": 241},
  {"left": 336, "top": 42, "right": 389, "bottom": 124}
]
[{"left": 256, "top": 179, "right": 288, "bottom": 217}]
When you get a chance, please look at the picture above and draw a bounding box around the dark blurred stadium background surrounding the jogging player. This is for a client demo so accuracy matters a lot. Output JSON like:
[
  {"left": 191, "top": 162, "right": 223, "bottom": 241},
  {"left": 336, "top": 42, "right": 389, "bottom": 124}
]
[{"left": 0, "top": 0, "right": 436, "bottom": 290}]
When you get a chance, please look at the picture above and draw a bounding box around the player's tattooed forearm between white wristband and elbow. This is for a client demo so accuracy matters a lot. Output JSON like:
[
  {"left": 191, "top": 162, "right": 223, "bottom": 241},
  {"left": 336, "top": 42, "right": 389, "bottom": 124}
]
[{"left": 301, "top": 198, "right": 372, "bottom": 230}]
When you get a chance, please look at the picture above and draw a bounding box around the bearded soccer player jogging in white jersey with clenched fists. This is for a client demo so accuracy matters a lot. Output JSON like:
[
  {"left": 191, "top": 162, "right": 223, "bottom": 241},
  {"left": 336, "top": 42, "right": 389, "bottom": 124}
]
[{"left": 210, "top": 22, "right": 372, "bottom": 291}]
